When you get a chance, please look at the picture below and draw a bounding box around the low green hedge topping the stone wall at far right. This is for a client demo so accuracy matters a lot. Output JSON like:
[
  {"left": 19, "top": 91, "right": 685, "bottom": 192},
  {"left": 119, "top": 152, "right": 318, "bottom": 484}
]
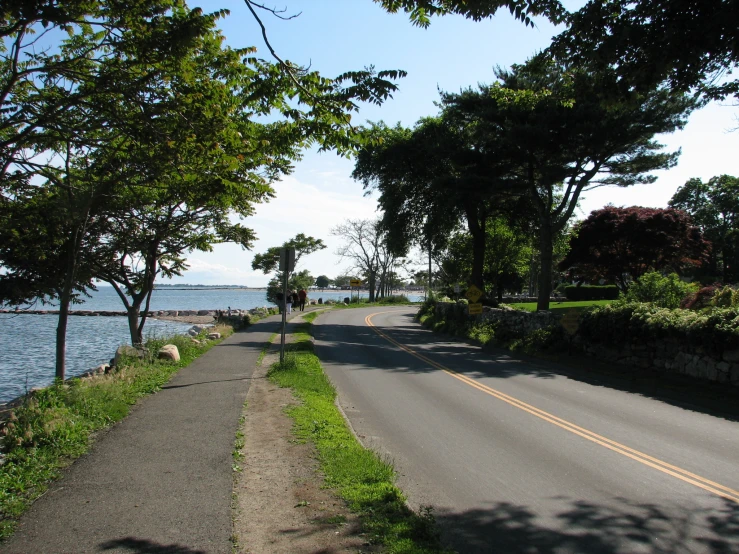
[{"left": 578, "top": 302, "right": 739, "bottom": 354}]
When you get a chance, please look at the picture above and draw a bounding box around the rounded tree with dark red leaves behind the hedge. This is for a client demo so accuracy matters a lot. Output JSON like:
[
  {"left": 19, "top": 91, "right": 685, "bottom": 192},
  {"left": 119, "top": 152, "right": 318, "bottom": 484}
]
[{"left": 559, "top": 206, "right": 711, "bottom": 290}]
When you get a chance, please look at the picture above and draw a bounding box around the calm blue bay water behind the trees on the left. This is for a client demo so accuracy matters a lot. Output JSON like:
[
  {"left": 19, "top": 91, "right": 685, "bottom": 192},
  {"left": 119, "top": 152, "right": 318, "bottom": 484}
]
[{"left": 0, "top": 287, "right": 418, "bottom": 403}]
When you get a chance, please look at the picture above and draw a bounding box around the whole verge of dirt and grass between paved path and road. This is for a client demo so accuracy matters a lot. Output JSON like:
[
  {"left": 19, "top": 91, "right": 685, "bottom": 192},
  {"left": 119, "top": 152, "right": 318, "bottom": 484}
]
[{"left": 234, "top": 313, "right": 448, "bottom": 554}]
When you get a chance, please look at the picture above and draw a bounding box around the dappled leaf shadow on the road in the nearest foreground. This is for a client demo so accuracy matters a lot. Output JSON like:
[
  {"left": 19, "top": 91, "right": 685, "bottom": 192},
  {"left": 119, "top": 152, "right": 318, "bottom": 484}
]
[{"left": 435, "top": 498, "right": 739, "bottom": 554}]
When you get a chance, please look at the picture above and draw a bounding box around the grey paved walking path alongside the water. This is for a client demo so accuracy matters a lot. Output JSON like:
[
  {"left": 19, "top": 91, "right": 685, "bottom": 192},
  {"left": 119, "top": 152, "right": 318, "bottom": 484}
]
[{"left": 0, "top": 310, "right": 300, "bottom": 554}]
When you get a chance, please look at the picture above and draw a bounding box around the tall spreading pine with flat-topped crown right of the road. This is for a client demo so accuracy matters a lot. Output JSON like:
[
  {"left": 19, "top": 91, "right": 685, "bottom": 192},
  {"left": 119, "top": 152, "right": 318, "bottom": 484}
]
[{"left": 443, "top": 55, "right": 695, "bottom": 310}]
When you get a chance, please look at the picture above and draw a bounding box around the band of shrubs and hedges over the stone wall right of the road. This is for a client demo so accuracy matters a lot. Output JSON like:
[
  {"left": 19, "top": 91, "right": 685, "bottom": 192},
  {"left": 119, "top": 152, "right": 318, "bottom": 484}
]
[{"left": 417, "top": 271, "right": 739, "bottom": 368}]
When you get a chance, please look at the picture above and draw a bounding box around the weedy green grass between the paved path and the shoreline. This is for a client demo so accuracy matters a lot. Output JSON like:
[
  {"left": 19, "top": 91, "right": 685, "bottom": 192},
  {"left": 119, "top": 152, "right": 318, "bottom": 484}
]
[{"left": 0, "top": 327, "right": 231, "bottom": 541}]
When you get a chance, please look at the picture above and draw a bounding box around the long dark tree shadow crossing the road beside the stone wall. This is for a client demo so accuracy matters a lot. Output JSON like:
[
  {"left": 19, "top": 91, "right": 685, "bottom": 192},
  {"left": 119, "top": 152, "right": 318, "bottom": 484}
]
[{"left": 315, "top": 314, "right": 739, "bottom": 421}]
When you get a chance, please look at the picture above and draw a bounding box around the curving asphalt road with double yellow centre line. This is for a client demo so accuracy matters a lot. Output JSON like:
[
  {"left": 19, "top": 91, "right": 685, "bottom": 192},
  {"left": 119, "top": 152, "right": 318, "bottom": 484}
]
[{"left": 315, "top": 307, "right": 739, "bottom": 553}]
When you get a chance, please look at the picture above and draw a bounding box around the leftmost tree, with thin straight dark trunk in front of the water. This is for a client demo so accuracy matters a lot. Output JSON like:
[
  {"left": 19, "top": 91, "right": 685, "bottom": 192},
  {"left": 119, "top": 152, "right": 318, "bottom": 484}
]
[{"left": 0, "top": 0, "right": 220, "bottom": 379}]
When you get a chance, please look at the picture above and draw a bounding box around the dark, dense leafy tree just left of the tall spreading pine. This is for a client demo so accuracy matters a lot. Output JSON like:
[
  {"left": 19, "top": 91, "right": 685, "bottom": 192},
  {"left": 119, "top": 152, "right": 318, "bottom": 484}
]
[{"left": 352, "top": 115, "right": 522, "bottom": 290}]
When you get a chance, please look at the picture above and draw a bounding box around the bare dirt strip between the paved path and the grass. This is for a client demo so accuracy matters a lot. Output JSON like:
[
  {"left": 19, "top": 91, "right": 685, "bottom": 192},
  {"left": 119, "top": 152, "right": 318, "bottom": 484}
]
[{"left": 234, "top": 318, "right": 375, "bottom": 554}]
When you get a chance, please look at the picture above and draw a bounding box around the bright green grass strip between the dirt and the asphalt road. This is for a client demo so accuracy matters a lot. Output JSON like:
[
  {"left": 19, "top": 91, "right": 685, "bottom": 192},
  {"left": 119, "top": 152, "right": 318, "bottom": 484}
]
[{"left": 268, "top": 312, "right": 449, "bottom": 554}]
